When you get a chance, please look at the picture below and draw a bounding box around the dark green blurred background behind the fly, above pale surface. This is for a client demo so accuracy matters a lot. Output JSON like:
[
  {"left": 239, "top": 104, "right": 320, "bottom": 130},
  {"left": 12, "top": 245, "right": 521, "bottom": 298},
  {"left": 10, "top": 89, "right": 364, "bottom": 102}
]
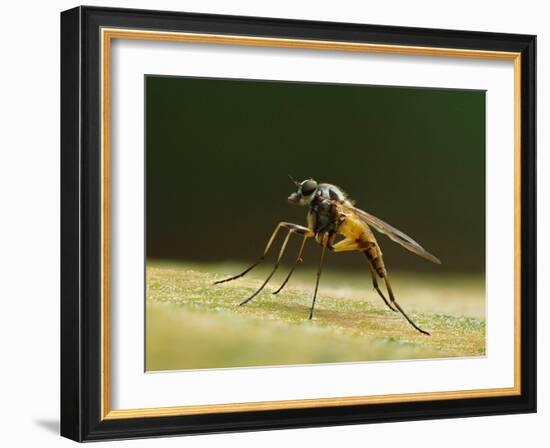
[{"left": 145, "top": 76, "right": 485, "bottom": 272}]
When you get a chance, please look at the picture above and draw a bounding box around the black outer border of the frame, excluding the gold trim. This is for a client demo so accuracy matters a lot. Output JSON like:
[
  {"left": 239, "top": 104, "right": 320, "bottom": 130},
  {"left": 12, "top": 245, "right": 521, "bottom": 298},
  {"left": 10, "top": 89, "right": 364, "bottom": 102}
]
[{"left": 61, "top": 6, "right": 537, "bottom": 441}]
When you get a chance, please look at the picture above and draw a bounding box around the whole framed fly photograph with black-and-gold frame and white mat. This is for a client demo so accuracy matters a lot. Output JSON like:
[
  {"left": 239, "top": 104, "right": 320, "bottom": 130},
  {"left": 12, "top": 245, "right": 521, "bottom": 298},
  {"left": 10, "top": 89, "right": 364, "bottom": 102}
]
[{"left": 61, "top": 7, "right": 536, "bottom": 441}]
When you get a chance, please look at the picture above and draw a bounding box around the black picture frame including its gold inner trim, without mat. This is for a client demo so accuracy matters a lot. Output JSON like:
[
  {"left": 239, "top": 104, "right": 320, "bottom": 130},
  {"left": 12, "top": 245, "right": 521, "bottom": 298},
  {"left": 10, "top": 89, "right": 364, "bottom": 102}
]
[{"left": 61, "top": 6, "right": 536, "bottom": 442}]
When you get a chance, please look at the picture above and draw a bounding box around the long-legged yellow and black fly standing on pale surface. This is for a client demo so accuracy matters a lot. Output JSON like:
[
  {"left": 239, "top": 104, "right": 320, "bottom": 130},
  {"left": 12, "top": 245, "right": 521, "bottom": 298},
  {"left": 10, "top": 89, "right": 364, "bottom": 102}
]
[{"left": 215, "top": 177, "right": 441, "bottom": 336}]
